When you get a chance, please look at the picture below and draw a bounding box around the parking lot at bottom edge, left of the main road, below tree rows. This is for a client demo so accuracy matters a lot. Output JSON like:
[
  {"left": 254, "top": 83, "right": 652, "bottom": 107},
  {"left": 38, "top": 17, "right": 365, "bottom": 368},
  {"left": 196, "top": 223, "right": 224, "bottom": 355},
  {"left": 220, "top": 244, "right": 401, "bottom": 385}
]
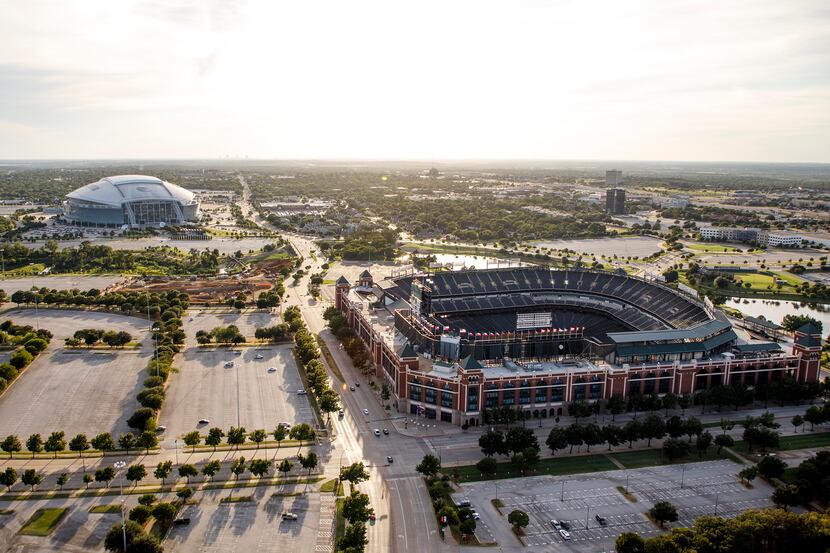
[{"left": 164, "top": 486, "right": 321, "bottom": 553}]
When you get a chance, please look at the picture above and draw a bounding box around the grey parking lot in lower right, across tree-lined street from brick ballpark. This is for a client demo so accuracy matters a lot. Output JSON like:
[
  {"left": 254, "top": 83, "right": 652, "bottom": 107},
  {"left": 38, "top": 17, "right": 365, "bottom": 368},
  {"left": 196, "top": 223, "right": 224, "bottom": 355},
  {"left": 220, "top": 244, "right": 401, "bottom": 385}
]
[{"left": 455, "top": 461, "right": 772, "bottom": 552}]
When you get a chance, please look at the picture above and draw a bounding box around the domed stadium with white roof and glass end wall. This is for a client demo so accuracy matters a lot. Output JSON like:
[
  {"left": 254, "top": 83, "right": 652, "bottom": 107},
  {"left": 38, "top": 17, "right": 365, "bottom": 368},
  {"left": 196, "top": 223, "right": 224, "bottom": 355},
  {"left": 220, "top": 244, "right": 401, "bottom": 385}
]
[{"left": 63, "top": 175, "right": 199, "bottom": 227}]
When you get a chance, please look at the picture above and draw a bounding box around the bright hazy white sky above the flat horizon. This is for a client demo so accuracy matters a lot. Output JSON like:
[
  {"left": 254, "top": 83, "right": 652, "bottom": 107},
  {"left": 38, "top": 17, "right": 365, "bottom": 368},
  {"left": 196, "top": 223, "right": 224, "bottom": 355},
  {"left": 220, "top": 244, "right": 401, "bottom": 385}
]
[{"left": 0, "top": 0, "right": 830, "bottom": 162}]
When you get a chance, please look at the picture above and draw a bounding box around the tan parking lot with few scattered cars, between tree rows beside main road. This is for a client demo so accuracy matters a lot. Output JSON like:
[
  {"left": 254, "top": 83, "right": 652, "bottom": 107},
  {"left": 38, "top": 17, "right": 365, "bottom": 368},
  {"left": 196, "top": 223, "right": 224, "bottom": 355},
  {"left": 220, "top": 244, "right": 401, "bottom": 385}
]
[{"left": 160, "top": 344, "right": 314, "bottom": 439}]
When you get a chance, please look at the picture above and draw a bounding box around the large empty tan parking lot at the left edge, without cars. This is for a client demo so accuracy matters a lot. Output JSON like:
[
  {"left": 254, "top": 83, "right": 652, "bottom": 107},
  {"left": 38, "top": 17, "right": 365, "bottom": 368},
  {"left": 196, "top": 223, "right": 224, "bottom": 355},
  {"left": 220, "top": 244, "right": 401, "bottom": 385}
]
[{"left": 0, "top": 348, "right": 150, "bottom": 438}]
